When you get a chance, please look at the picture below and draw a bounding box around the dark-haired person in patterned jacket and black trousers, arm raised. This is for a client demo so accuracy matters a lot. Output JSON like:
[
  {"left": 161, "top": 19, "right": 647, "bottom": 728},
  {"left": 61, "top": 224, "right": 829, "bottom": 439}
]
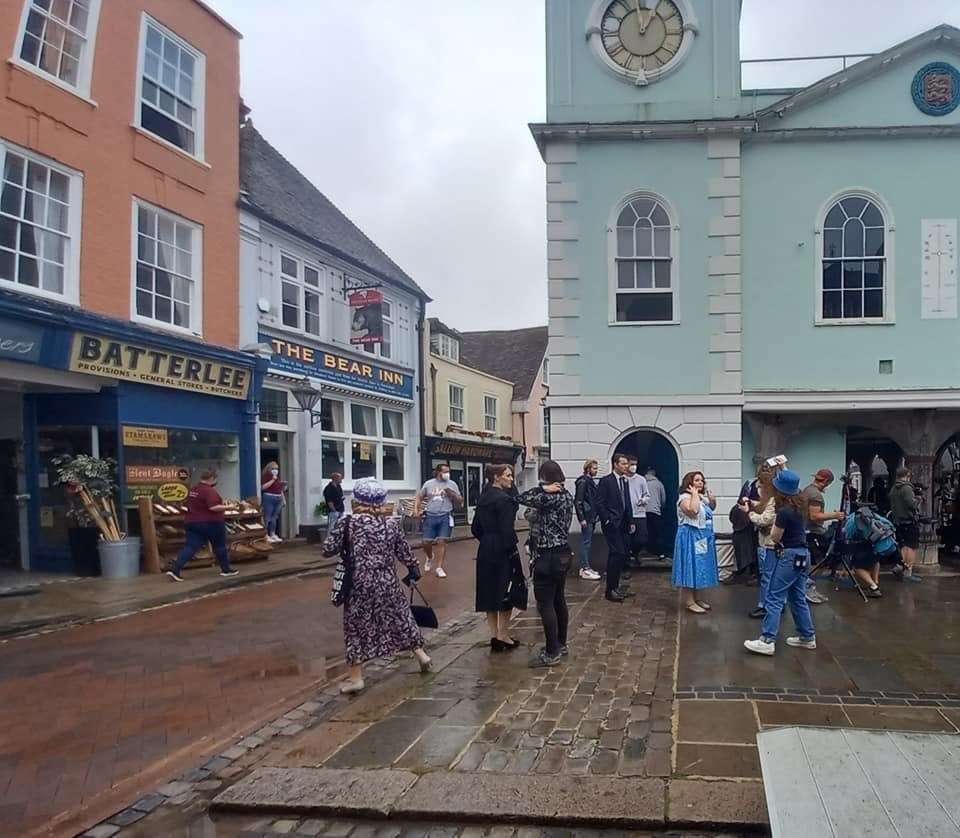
[{"left": 519, "top": 460, "right": 574, "bottom": 668}]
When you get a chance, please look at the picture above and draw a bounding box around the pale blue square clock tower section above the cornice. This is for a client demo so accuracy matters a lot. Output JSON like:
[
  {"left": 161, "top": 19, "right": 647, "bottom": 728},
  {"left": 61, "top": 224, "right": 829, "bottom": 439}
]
[{"left": 547, "top": 0, "right": 740, "bottom": 122}]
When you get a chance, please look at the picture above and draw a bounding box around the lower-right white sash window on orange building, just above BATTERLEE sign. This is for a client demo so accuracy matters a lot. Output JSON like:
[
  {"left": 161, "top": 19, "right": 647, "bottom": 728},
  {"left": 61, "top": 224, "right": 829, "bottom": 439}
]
[{"left": 134, "top": 202, "right": 202, "bottom": 334}]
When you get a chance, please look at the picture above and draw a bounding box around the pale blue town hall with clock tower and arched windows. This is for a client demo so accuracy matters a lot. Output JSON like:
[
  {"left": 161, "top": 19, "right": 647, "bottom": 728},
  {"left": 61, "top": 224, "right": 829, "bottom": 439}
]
[{"left": 531, "top": 0, "right": 960, "bottom": 561}]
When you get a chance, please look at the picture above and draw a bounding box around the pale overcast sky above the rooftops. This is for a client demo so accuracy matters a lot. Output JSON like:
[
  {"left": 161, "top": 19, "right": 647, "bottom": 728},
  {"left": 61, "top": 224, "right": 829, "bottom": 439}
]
[{"left": 207, "top": 0, "right": 960, "bottom": 330}]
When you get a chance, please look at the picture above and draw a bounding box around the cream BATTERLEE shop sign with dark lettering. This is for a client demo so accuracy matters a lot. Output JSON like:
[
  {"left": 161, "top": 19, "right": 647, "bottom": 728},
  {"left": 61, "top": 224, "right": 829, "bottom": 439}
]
[{"left": 70, "top": 332, "right": 250, "bottom": 399}]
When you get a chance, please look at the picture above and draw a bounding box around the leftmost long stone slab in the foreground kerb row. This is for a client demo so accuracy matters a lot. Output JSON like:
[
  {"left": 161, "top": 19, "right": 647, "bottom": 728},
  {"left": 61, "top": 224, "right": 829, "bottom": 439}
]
[{"left": 212, "top": 768, "right": 417, "bottom": 817}]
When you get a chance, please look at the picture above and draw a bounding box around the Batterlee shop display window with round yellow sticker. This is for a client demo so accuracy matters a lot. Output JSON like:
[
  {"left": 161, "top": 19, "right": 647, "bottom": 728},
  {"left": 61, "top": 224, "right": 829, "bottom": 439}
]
[{"left": 120, "top": 428, "right": 240, "bottom": 505}]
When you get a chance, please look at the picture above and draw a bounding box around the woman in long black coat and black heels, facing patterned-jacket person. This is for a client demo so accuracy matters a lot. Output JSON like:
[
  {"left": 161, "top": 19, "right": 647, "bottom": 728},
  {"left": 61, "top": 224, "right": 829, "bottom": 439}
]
[{"left": 470, "top": 465, "right": 522, "bottom": 652}]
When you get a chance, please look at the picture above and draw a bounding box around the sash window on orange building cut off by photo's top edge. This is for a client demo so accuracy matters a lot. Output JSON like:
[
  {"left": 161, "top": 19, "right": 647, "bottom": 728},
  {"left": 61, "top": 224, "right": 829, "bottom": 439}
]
[{"left": 15, "top": 0, "right": 100, "bottom": 97}]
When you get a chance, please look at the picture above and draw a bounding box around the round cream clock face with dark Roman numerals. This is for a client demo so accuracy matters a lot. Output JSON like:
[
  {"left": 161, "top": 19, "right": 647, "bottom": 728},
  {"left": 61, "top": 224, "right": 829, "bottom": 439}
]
[{"left": 600, "top": 0, "right": 683, "bottom": 73}]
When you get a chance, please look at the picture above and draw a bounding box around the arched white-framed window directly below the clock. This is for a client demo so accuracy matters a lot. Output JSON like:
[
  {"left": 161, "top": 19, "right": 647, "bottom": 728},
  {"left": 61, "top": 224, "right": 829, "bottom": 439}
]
[{"left": 612, "top": 195, "right": 676, "bottom": 323}]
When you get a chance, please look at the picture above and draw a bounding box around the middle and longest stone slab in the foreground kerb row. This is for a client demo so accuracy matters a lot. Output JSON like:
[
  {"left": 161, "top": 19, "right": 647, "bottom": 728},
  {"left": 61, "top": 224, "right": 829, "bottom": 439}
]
[{"left": 392, "top": 772, "right": 666, "bottom": 828}]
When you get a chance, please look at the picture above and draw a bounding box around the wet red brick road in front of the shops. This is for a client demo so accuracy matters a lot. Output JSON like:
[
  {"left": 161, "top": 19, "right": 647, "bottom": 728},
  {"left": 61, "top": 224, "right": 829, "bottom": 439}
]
[{"left": 0, "top": 543, "right": 474, "bottom": 835}]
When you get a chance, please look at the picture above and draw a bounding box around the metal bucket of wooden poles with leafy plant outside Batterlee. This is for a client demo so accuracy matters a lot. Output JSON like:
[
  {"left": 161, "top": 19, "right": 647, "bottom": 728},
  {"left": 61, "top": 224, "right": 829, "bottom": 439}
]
[{"left": 53, "top": 454, "right": 140, "bottom": 579}]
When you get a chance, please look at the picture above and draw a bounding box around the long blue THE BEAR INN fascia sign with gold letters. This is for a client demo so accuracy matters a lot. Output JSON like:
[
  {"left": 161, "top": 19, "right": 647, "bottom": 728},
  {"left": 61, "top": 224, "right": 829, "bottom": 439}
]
[{"left": 260, "top": 334, "right": 413, "bottom": 399}]
